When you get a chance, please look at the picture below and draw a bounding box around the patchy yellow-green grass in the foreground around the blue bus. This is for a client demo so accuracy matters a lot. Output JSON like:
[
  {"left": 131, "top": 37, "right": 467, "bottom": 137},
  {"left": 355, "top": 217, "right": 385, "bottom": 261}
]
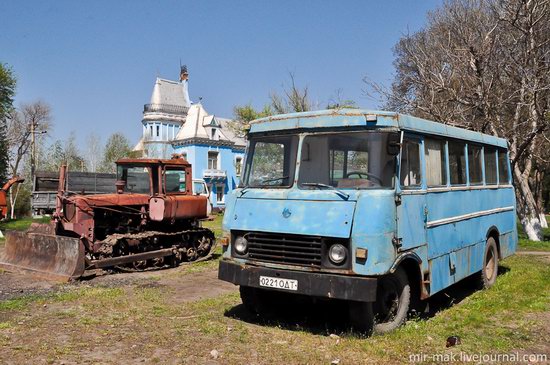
[{"left": 0, "top": 256, "right": 550, "bottom": 364}]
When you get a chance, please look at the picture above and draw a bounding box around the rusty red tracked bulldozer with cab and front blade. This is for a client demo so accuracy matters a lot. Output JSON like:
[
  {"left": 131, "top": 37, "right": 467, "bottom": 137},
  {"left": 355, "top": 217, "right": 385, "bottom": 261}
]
[{"left": 0, "top": 156, "right": 214, "bottom": 281}]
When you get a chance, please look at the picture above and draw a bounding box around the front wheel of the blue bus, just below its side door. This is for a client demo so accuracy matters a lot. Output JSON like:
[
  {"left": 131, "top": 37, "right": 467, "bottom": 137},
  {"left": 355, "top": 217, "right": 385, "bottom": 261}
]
[{"left": 373, "top": 267, "right": 411, "bottom": 333}]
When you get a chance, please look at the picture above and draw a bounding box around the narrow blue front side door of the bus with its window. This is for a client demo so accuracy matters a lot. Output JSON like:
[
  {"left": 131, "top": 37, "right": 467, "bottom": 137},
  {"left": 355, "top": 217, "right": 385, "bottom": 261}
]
[{"left": 396, "top": 134, "right": 427, "bottom": 250}]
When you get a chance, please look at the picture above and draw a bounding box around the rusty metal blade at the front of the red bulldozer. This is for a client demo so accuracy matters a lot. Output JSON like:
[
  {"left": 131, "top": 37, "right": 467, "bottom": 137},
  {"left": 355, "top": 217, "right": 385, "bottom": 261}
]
[{"left": 0, "top": 230, "right": 85, "bottom": 281}]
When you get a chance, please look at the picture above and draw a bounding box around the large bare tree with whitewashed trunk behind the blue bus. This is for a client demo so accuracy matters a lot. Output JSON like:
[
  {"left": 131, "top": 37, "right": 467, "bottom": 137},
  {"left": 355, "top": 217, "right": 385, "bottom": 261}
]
[{"left": 365, "top": 0, "right": 550, "bottom": 240}]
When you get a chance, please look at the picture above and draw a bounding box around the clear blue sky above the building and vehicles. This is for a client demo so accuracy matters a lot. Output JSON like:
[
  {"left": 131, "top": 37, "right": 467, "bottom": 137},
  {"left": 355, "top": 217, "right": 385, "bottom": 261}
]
[{"left": 0, "top": 0, "right": 441, "bottom": 147}]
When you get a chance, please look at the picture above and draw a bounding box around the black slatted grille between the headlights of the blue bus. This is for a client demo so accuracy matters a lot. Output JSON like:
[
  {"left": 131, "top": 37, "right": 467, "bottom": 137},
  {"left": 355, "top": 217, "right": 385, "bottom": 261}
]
[{"left": 246, "top": 232, "right": 322, "bottom": 267}]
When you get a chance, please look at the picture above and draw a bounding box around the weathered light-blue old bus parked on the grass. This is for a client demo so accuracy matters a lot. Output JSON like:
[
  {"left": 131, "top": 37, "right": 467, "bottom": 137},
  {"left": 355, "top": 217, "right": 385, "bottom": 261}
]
[{"left": 218, "top": 109, "right": 517, "bottom": 333}]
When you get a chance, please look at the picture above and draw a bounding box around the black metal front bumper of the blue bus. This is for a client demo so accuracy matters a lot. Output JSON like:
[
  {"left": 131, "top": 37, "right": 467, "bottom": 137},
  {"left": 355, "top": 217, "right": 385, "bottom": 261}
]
[{"left": 218, "top": 260, "right": 377, "bottom": 302}]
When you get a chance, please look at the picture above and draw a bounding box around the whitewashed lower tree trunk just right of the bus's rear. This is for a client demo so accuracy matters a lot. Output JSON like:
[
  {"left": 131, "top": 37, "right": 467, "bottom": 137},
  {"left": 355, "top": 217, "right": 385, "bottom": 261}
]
[{"left": 514, "top": 164, "right": 542, "bottom": 241}]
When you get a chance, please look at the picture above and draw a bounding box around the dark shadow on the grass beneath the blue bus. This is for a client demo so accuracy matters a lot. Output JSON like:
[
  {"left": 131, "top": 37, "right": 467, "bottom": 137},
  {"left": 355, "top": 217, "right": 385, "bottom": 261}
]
[{"left": 225, "top": 266, "right": 510, "bottom": 336}]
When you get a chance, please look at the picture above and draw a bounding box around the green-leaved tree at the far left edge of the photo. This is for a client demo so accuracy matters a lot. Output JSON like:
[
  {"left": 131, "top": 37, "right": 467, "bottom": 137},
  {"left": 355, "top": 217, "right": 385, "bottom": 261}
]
[{"left": 0, "top": 63, "right": 16, "bottom": 183}]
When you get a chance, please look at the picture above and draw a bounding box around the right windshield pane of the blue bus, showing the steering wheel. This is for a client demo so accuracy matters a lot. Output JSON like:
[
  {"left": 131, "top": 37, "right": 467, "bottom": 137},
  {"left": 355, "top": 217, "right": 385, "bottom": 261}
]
[{"left": 298, "top": 132, "right": 395, "bottom": 189}]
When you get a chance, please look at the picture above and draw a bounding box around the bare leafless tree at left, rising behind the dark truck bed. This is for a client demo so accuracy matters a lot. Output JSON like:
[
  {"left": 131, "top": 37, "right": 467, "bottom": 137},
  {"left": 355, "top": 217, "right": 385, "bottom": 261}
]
[{"left": 7, "top": 101, "right": 51, "bottom": 219}]
